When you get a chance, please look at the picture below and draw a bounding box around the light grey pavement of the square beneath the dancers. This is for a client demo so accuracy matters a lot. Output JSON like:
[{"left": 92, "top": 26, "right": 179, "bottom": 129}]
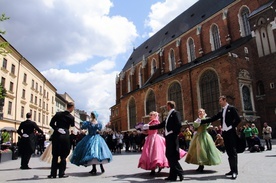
[{"left": 0, "top": 145, "right": 276, "bottom": 183}]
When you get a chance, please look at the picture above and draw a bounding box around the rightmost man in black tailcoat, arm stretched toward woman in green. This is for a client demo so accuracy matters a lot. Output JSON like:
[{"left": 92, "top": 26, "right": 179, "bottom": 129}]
[{"left": 201, "top": 96, "right": 241, "bottom": 179}]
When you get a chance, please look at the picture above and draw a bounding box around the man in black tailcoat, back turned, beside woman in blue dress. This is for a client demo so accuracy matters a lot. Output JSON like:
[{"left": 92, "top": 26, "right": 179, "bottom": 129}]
[{"left": 48, "top": 102, "right": 75, "bottom": 178}]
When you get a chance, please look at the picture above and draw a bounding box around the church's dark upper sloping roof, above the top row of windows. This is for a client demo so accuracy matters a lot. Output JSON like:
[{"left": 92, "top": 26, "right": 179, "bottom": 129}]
[{"left": 123, "top": 0, "right": 235, "bottom": 71}]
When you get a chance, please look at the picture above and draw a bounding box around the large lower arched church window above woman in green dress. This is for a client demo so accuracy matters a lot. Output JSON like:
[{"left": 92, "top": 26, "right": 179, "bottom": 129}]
[{"left": 199, "top": 70, "right": 220, "bottom": 116}]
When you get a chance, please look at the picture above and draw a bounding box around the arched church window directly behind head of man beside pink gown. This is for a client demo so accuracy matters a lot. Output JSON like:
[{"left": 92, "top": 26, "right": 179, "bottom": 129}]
[{"left": 168, "top": 82, "right": 184, "bottom": 121}]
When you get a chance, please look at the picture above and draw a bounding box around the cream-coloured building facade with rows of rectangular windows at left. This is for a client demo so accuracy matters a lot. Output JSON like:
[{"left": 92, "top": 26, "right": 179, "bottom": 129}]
[{"left": 0, "top": 36, "right": 56, "bottom": 142}]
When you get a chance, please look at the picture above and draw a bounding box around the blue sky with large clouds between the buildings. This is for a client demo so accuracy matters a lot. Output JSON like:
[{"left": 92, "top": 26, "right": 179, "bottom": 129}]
[{"left": 0, "top": 0, "right": 197, "bottom": 124}]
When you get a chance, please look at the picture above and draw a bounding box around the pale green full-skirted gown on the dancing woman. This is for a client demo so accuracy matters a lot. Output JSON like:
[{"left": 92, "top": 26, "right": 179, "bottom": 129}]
[{"left": 185, "top": 122, "right": 221, "bottom": 165}]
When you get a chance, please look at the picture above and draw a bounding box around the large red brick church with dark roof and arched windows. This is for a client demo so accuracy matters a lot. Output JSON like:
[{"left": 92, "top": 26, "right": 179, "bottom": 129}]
[{"left": 110, "top": 0, "right": 276, "bottom": 134}]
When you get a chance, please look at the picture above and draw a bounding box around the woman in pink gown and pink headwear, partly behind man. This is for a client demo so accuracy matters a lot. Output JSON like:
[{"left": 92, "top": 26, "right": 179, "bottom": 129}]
[{"left": 138, "top": 111, "right": 186, "bottom": 175}]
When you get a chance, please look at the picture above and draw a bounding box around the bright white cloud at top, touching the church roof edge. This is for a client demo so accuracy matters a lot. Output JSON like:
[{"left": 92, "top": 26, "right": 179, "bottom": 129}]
[{"left": 145, "top": 0, "right": 198, "bottom": 36}]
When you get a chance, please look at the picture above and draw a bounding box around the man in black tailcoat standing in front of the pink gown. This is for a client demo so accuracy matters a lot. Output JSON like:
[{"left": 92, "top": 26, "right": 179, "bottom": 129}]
[{"left": 143, "top": 101, "right": 183, "bottom": 181}]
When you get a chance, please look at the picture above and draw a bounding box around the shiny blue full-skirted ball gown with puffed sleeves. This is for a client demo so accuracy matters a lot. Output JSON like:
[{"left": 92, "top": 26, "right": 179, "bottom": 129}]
[{"left": 70, "top": 121, "right": 112, "bottom": 166}]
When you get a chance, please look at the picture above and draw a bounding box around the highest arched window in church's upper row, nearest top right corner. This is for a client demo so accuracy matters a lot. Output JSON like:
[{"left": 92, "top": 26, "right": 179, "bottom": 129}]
[{"left": 239, "top": 7, "right": 251, "bottom": 37}]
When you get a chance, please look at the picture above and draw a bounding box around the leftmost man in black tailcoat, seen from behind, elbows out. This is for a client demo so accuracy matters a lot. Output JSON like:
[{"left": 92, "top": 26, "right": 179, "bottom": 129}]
[{"left": 17, "top": 113, "right": 43, "bottom": 170}]
